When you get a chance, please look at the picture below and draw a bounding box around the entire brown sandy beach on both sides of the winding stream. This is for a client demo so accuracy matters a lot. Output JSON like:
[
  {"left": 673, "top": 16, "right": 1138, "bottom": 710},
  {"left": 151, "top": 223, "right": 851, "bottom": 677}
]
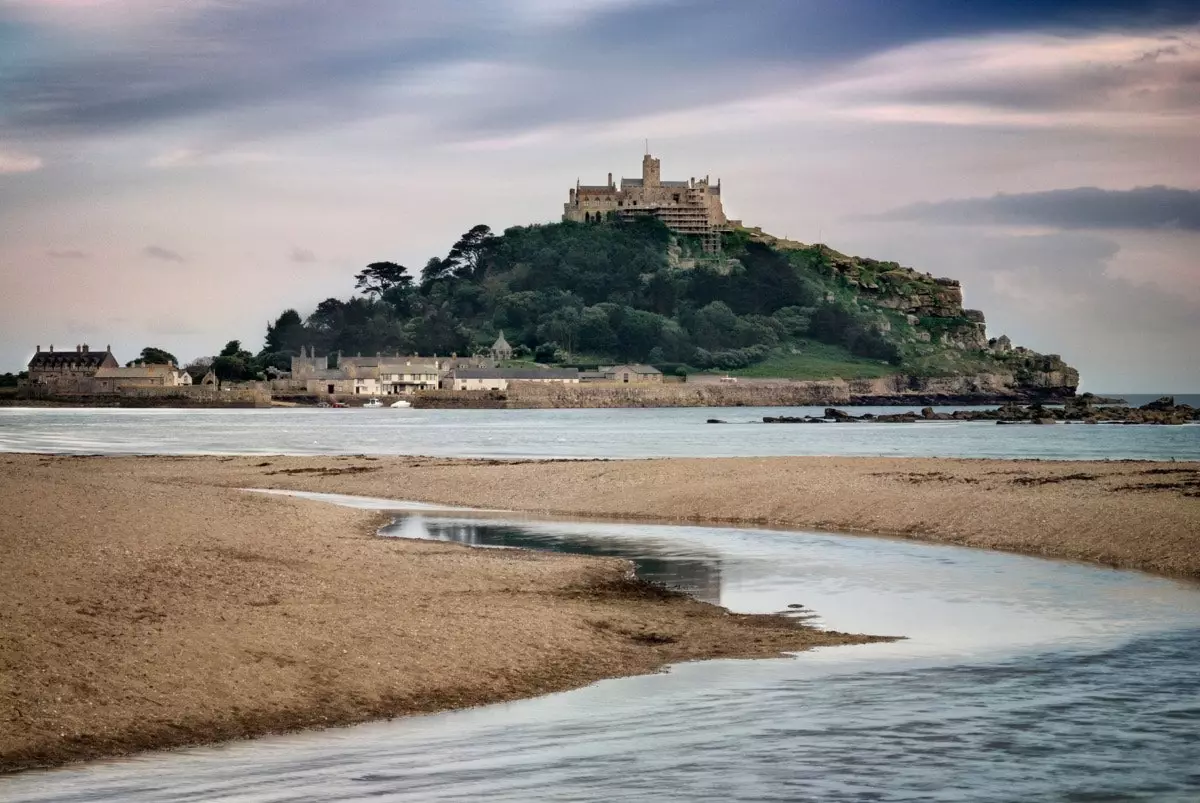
[{"left": 0, "top": 455, "right": 1200, "bottom": 771}]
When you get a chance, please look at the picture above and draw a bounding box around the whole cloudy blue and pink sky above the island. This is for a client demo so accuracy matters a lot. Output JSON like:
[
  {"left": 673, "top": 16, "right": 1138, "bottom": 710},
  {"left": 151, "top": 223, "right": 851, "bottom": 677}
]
[{"left": 0, "top": 0, "right": 1200, "bottom": 392}]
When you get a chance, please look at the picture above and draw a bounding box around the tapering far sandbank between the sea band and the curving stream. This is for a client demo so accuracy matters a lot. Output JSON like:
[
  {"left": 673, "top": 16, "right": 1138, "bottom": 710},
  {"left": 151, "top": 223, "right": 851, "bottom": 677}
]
[{"left": 189, "top": 457, "right": 1200, "bottom": 579}]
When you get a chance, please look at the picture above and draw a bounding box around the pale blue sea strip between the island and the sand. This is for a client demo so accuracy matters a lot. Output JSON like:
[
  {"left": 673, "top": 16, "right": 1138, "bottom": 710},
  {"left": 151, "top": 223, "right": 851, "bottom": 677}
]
[{"left": 0, "top": 407, "right": 1200, "bottom": 460}]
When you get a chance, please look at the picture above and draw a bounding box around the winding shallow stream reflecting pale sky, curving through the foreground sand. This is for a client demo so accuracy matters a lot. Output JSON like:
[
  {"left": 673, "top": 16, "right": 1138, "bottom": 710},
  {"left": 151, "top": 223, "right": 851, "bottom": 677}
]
[{"left": 11, "top": 503, "right": 1200, "bottom": 803}]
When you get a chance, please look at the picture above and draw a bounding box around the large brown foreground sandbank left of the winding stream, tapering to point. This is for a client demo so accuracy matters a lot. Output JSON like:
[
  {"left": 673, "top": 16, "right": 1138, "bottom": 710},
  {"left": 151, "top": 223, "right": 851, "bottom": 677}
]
[{"left": 0, "top": 455, "right": 883, "bottom": 772}]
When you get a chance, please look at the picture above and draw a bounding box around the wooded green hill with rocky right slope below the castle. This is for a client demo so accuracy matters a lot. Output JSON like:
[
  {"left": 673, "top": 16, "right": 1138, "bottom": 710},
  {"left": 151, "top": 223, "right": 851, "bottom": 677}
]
[{"left": 246, "top": 218, "right": 1079, "bottom": 395}]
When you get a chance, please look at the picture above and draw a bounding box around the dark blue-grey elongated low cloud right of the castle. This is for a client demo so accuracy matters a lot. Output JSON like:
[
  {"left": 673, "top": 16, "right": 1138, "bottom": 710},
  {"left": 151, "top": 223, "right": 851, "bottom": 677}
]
[{"left": 874, "top": 186, "right": 1200, "bottom": 232}]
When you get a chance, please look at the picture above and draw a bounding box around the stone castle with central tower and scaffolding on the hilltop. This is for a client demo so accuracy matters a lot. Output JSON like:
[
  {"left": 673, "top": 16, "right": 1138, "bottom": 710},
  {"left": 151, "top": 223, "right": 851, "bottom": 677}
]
[{"left": 563, "top": 154, "right": 730, "bottom": 251}]
